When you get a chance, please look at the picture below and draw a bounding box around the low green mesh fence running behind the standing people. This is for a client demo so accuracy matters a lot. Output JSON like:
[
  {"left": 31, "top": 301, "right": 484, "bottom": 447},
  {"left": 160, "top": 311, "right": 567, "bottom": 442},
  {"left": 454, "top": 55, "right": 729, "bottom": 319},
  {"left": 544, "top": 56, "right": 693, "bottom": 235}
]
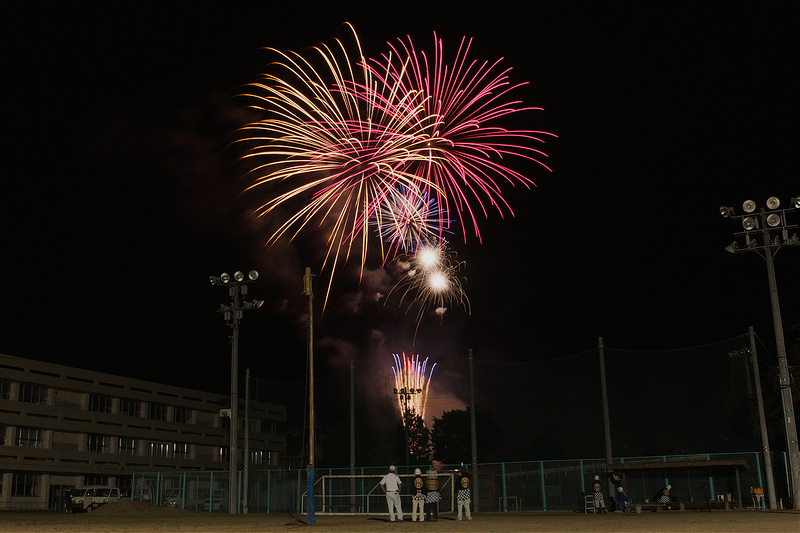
[{"left": 132, "top": 452, "right": 780, "bottom": 514}]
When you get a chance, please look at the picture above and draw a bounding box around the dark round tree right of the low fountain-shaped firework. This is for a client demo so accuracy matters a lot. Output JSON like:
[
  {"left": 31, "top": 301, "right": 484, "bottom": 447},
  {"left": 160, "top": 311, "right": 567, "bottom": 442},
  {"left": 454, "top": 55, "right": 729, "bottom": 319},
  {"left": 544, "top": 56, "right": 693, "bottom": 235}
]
[{"left": 431, "top": 407, "right": 505, "bottom": 464}]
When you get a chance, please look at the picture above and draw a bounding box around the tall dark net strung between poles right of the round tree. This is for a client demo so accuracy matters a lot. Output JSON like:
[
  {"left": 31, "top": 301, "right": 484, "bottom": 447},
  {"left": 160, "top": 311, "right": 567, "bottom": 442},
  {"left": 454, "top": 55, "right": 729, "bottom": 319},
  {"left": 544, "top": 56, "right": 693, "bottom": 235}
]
[{"left": 474, "top": 335, "right": 760, "bottom": 460}]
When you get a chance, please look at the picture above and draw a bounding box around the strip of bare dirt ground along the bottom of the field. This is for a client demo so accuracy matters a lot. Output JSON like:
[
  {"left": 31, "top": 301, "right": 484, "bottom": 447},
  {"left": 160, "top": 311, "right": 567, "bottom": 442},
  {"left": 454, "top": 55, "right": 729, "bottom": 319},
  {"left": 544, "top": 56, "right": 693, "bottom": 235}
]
[{"left": 0, "top": 502, "right": 800, "bottom": 533}]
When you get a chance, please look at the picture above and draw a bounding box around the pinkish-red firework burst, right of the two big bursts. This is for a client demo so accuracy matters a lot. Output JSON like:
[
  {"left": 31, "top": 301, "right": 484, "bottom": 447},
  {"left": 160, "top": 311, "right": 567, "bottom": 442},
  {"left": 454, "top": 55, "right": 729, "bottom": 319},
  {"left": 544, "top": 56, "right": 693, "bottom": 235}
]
[{"left": 371, "top": 34, "right": 553, "bottom": 240}]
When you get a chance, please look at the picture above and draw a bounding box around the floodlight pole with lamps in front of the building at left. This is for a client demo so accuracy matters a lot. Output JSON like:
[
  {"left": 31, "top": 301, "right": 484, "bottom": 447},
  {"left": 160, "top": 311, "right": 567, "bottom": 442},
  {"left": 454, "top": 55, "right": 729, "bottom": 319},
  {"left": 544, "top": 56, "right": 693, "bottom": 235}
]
[{"left": 209, "top": 270, "right": 264, "bottom": 514}]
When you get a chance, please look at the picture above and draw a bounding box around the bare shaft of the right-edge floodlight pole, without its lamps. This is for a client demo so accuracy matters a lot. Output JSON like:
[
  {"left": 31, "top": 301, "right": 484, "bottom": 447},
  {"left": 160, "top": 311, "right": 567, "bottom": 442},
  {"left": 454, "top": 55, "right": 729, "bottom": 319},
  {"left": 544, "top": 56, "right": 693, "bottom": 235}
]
[{"left": 764, "top": 238, "right": 800, "bottom": 510}]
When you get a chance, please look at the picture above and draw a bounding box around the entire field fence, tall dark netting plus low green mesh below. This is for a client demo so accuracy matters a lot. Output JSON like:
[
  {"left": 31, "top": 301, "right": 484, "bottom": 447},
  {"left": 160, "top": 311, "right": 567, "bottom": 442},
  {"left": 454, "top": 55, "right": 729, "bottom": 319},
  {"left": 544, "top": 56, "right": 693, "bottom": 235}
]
[{"left": 133, "top": 335, "right": 789, "bottom": 513}]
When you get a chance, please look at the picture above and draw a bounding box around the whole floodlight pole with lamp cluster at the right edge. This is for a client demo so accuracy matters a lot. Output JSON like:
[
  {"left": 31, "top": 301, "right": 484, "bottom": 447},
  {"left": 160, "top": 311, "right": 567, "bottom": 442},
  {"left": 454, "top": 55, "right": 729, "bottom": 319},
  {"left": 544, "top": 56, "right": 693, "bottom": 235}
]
[{"left": 719, "top": 196, "right": 800, "bottom": 509}]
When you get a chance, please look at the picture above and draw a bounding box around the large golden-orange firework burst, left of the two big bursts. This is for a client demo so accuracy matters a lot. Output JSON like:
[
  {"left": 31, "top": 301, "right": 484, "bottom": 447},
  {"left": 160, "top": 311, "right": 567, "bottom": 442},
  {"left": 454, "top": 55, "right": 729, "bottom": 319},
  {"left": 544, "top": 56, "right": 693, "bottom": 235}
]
[{"left": 234, "top": 22, "right": 435, "bottom": 301}]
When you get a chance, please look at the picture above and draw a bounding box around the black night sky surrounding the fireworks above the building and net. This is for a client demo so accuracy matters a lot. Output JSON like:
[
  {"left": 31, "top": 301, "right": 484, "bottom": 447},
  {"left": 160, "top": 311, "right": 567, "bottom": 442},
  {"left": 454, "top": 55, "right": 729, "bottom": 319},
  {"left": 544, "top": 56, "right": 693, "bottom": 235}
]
[{"left": 0, "top": 1, "right": 800, "bottom": 458}]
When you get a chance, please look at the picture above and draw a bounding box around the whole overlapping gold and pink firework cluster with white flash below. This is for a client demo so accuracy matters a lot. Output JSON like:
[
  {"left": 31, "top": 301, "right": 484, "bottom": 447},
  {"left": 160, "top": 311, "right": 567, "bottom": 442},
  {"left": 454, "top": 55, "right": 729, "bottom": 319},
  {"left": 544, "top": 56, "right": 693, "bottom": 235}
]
[{"left": 234, "top": 25, "right": 551, "bottom": 312}]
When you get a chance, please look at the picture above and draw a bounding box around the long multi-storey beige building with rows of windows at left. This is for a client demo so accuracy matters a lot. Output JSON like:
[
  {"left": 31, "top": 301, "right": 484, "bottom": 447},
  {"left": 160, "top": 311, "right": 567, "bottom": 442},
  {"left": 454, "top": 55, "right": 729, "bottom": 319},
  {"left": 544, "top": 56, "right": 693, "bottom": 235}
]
[{"left": 0, "top": 354, "right": 286, "bottom": 510}]
